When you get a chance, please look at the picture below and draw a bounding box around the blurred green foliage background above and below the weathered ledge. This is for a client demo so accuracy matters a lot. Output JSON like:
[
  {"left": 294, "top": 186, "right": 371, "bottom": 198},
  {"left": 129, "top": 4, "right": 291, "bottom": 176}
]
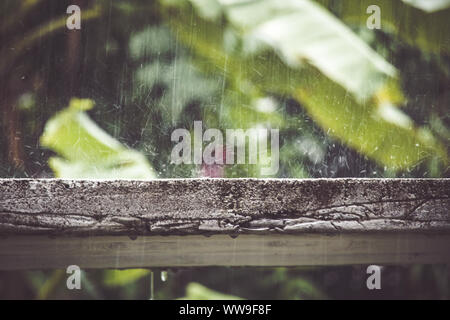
[{"left": 0, "top": 0, "right": 450, "bottom": 298}]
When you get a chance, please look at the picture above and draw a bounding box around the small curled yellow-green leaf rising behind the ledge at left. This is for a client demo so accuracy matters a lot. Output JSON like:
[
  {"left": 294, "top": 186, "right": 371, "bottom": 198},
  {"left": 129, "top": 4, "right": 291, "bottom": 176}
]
[{"left": 41, "top": 99, "right": 155, "bottom": 179}]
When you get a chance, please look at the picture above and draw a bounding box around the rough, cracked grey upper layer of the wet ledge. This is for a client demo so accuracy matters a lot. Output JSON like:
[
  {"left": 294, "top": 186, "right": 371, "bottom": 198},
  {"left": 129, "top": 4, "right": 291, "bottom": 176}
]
[{"left": 0, "top": 179, "right": 450, "bottom": 236}]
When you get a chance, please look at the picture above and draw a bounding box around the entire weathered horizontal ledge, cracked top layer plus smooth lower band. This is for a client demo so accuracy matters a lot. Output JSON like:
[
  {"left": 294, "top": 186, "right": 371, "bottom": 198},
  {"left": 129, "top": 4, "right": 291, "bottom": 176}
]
[{"left": 0, "top": 179, "right": 450, "bottom": 269}]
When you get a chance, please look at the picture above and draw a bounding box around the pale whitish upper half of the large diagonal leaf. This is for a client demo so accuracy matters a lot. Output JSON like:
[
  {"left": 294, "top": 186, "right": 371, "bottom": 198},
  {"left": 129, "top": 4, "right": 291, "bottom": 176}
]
[{"left": 196, "top": 0, "right": 396, "bottom": 99}]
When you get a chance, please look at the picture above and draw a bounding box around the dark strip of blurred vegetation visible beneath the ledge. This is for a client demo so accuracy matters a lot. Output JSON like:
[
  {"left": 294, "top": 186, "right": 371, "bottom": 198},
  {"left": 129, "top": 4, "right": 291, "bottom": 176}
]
[{"left": 0, "top": 265, "right": 450, "bottom": 300}]
